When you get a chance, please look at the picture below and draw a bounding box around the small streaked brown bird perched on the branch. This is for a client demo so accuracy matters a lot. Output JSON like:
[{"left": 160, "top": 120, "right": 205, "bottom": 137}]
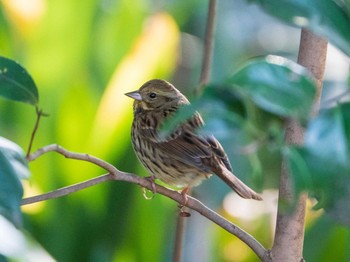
[{"left": 126, "top": 79, "right": 262, "bottom": 200}]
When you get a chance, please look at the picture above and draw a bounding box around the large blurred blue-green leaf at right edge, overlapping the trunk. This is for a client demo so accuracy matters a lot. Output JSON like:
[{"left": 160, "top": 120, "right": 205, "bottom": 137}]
[{"left": 284, "top": 103, "right": 350, "bottom": 225}]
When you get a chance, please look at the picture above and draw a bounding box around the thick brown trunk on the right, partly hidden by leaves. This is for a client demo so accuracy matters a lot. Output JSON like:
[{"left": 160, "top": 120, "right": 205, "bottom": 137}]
[{"left": 271, "top": 29, "right": 327, "bottom": 262}]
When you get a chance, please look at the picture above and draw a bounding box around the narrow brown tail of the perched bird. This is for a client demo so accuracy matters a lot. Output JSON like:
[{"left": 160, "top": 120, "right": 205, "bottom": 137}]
[{"left": 216, "top": 166, "right": 262, "bottom": 200}]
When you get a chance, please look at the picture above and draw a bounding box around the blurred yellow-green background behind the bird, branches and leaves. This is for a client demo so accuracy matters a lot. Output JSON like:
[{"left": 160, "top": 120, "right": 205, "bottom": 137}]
[{"left": 0, "top": 0, "right": 350, "bottom": 262}]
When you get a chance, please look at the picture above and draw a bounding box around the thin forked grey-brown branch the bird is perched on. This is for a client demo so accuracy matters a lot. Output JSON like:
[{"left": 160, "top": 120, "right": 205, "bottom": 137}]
[{"left": 22, "top": 144, "right": 269, "bottom": 261}]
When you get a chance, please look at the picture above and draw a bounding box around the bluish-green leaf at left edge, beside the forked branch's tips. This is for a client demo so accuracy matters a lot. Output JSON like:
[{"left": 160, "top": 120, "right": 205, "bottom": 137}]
[{"left": 0, "top": 137, "right": 29, "bottom": 226}]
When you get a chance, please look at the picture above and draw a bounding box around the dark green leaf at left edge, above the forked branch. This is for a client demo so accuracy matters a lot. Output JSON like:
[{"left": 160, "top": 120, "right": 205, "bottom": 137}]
[{"left": 0, "top": 56, "right": 39, "bottom": 105}]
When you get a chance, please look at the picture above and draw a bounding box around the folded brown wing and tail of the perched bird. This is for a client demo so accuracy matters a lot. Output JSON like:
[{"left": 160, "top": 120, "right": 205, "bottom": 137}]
[{"left": 138, "top": 113, "right": 262, "bottom": 200}]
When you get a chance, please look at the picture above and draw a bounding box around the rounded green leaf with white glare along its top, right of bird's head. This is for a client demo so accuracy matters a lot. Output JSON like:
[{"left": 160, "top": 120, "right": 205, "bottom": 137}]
[{"left": 229, "top": 56, "right": 316, "bottom": 119}]
